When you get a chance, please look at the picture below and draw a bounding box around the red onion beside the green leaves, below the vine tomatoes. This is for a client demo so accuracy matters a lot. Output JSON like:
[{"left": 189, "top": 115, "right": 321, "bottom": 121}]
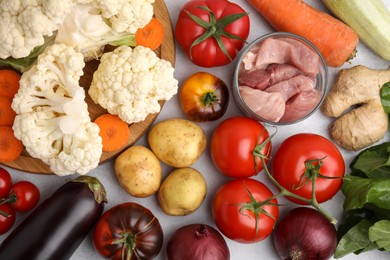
[{"left": 274, "top": 207, "right": 337, "bottom": 260}]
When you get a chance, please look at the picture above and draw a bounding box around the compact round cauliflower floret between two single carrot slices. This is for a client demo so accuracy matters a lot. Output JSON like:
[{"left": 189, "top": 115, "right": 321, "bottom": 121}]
[{"left": 88, "top": 46, "right": 178, "bottom": 124}]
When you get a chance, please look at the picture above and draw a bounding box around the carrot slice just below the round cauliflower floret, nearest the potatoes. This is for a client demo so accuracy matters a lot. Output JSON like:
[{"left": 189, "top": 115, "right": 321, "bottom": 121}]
[{"left": 94, "top": 114, "right": 130, "bottom": 152}]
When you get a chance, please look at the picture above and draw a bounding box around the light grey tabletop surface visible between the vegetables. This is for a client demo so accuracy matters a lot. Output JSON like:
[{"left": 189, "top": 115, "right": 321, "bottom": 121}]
[{"left": 0, "top": 0, "right": 390, "bottom": 260}]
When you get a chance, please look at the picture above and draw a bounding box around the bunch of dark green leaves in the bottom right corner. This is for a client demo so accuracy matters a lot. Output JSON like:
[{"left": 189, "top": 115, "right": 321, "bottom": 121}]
[{"left": 334, "top": 142, "right": 390, "bottom": 258}]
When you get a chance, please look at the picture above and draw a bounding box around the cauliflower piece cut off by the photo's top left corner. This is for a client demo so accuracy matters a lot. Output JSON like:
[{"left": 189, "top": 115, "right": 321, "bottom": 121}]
[{"left": 0, "top": 0, "right": 73, "bottom": 59}]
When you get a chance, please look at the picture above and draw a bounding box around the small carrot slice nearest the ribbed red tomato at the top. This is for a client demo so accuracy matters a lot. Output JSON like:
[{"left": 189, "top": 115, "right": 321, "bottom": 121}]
[{"left": 135, "top": 17, "right": 164, "bottom": 50}]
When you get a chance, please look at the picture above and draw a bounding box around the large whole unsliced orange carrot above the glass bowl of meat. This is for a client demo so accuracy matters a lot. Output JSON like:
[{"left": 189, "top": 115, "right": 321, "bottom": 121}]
[{"left": 247, "top": 0, "right": 359, "bottom": 67}]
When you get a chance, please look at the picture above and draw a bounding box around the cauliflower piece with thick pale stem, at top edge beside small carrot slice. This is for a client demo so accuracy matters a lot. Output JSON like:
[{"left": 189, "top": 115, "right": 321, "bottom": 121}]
[{"left": 56, "top": 0, "right": 154, "bottom": 60}]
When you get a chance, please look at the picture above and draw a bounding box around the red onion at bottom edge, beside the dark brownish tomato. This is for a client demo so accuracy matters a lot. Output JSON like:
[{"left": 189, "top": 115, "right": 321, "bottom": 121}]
[{"left": 166, "top": 224, "right": 230, "bottom": 260}]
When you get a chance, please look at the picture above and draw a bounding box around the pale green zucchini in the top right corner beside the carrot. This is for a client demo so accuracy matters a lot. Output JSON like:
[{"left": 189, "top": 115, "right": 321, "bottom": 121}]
[{"left": 322, "top": 0, "right": 390, "bottom": 60}]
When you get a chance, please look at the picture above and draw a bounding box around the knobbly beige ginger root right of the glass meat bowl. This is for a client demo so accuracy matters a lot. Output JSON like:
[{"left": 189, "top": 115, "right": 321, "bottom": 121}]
[{"left": 321, "top": 65, "right": 390, "bottom": 151}]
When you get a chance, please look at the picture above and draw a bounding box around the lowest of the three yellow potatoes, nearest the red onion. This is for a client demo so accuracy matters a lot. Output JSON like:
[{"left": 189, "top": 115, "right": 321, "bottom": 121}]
[{"left": 157, "top": 167, "right": 207, "bottom": 216}]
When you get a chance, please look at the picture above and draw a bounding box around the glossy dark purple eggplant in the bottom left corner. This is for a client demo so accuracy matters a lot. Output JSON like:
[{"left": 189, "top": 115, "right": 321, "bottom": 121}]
[{"left": 0, "top": 176, "right": 107, "bottom": 260}]
